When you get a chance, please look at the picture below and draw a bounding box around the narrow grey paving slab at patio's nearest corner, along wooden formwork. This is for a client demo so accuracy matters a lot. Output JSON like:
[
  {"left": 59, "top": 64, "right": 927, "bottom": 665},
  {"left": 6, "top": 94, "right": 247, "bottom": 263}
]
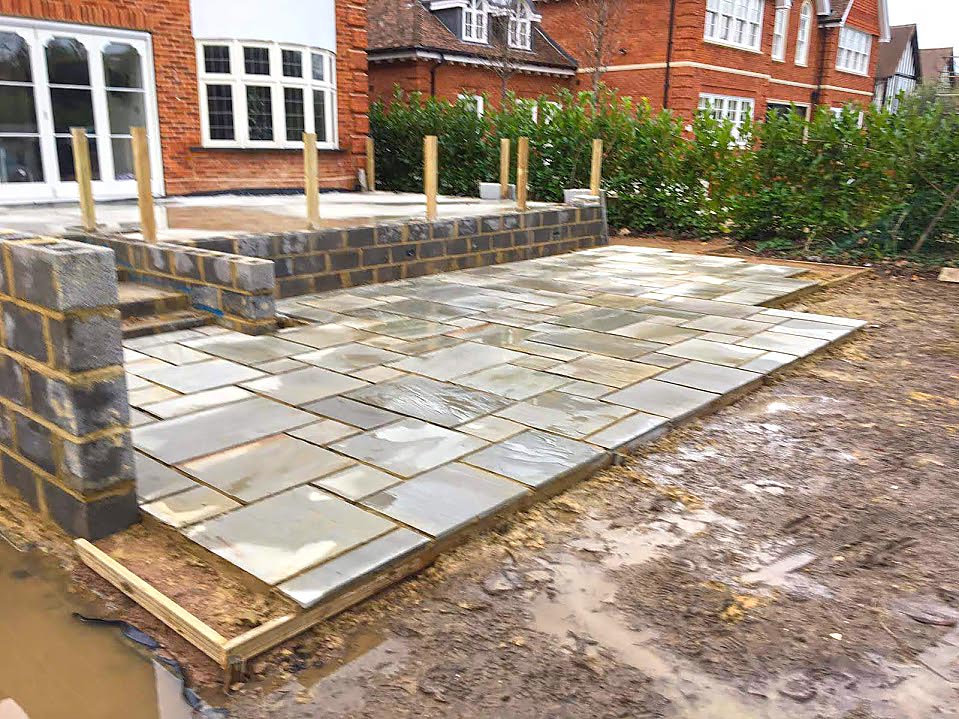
[{"left": 277, "top": 527, "right": 430, "bottom": 609}]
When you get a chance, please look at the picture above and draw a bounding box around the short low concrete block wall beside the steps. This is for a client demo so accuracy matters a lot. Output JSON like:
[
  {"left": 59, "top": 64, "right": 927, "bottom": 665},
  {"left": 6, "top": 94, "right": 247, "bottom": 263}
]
[{"left": 72, "top": 234, "right": 276, "bottom": 335}]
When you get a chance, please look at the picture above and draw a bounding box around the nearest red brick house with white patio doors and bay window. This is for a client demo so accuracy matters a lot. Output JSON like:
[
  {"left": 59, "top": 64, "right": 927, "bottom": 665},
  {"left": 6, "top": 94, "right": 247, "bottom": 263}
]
[{"left": 0, "top": 0, "right": 369, "bottom": 203}]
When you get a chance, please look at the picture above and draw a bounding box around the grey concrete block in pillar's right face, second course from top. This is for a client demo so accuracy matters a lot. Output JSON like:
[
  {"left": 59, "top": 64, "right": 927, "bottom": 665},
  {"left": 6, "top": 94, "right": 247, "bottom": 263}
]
[{"left": 47, "top": 312, "right": 123, "bottom": 372}]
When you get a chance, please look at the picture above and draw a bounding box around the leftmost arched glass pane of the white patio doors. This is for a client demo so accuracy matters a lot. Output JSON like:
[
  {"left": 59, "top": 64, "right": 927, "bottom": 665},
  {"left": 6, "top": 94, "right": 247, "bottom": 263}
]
[{"left": 0, "top": 31, "right": 44, "bottom": 184}]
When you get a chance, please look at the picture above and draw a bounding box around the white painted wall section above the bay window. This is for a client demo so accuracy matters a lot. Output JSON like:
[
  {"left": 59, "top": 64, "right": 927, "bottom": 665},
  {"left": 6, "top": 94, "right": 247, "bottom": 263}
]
[{"left": 190, "top": 0, "right": 336, "bottom": 52}]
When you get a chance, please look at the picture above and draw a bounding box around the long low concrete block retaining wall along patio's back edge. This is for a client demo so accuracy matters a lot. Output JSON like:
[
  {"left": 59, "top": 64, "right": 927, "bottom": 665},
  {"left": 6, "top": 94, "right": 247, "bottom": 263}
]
[{"left": 185, "top": 203, "right": 608, "bottom": 298}]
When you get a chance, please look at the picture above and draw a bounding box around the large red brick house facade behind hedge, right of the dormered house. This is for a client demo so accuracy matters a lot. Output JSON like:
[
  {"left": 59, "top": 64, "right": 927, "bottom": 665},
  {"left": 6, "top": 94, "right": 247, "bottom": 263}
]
[{"left": 537, "top": 0, "right": 890, "bottom": 129}]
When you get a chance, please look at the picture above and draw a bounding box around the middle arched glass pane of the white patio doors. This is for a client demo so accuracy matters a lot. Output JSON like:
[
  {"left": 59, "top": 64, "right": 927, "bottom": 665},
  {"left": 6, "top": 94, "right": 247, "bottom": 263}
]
[{"left": 46, "top": 37, "right": 100, "bottom": 182}]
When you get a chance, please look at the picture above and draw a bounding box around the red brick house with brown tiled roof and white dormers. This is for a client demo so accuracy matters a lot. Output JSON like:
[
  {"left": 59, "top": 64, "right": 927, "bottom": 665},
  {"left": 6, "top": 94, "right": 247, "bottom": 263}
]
[{"left": 368, "top": 0, "right": 576, "bottom": 110}]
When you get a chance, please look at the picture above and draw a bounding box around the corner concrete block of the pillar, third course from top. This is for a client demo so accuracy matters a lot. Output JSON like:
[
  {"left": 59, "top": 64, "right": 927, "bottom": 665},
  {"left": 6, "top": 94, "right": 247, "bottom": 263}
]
[{"left": 29, "top": 371, "right": 130, "bottom": 436}]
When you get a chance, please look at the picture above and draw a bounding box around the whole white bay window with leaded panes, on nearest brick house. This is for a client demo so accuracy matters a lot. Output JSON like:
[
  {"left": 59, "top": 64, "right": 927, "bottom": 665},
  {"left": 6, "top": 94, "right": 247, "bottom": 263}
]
[{"left": 197, "top": 40, "right": 337, "bottom": 148}]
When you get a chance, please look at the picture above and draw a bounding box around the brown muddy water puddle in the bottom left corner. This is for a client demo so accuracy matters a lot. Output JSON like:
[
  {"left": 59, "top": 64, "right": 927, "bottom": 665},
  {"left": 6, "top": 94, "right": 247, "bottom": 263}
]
[{"left": 0, "top": 538, "right": 192, "bottom": 719}]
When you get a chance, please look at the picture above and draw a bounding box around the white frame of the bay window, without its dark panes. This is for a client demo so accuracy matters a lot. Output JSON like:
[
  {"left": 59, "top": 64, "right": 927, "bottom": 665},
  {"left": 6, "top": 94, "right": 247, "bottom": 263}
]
[{"left": 196, "top": 39, "right": 339, "bottom": 150}]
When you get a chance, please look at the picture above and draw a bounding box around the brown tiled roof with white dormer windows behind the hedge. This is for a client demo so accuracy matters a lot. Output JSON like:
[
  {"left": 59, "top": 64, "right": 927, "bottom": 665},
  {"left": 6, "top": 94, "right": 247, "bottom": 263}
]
[{"left": 366, "top": 0, "right": 576, "bottom": 70}]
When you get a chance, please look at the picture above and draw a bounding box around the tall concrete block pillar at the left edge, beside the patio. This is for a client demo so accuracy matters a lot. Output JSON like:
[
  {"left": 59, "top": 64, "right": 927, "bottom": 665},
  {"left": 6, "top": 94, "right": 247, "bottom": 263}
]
[{"left": 0, "top": 239, "right": 139, "bottom": 539}]
